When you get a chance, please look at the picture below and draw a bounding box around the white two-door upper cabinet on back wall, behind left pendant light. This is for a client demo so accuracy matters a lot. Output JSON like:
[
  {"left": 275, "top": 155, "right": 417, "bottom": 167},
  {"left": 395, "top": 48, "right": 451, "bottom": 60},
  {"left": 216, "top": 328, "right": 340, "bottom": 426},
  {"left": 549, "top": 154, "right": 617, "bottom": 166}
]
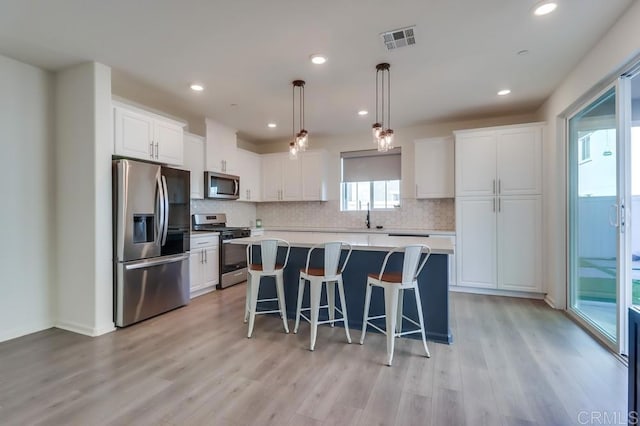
[{"left": 262, "top": 153, "right": 302, "bottom": 201}]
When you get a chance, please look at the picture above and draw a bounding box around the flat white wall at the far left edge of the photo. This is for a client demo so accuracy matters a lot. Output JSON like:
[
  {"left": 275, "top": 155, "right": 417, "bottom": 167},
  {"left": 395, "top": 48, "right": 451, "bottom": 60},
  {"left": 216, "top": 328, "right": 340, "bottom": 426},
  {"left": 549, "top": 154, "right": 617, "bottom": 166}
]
[{"left": 0, "top": 56, "right": 55, "bottom": 341}]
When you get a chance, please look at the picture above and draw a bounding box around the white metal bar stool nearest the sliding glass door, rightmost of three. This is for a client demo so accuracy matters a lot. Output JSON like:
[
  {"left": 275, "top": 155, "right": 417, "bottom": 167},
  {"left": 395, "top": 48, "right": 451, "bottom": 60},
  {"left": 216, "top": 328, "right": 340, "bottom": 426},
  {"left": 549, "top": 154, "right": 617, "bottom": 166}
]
[{"left": 360, "top": 244, "right": 431, "bottom": 366}]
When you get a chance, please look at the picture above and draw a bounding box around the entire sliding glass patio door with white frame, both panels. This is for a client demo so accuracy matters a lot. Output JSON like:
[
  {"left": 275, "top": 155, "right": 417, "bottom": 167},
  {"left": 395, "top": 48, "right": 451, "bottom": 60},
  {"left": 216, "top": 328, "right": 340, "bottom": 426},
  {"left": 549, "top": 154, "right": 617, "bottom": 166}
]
[{"left": 568, "top": 71, "right": 640, "bottom": 354}]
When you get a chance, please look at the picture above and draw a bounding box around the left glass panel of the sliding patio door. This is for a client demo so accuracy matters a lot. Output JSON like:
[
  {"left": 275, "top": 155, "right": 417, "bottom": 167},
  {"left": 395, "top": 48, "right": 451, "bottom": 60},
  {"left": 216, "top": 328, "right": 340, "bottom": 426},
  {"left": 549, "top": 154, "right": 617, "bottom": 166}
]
[{"left": 569, "top": 86, "right": 621, "bottom": 348}]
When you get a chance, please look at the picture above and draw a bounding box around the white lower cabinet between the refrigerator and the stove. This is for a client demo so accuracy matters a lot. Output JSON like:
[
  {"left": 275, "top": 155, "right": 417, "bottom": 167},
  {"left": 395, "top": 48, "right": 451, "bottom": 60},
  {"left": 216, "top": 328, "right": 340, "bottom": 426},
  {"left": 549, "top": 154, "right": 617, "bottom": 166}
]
[{"left": 189, "top": 234, "right": 220, "bottom": 298}]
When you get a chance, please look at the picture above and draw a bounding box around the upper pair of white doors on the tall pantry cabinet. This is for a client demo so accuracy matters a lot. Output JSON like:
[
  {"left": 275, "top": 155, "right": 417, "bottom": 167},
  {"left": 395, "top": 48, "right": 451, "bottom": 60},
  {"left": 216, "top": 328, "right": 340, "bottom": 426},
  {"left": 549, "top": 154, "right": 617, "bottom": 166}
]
[{"left": 455, "top": 124, "right": 544, "bottom": 196}]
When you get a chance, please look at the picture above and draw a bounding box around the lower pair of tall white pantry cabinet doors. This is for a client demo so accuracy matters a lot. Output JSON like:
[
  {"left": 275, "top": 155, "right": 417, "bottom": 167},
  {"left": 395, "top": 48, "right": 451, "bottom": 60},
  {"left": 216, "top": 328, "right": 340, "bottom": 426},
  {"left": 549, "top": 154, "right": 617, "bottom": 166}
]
[{"left": 456, "top": 195, "right": 542, "bottom": 293}]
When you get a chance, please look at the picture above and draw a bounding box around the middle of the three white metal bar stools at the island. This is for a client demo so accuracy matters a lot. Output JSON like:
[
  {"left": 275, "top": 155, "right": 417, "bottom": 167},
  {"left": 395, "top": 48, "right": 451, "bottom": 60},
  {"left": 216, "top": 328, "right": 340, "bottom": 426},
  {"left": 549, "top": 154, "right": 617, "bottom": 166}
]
[{"left": 293, "top": 241, "right": 352, "bottom": 350}]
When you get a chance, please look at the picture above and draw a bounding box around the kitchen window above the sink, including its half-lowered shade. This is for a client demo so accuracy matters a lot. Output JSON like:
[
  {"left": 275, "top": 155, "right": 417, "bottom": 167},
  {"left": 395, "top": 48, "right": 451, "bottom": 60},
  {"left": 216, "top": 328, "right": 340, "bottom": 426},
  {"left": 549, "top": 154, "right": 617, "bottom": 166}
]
[{"left": 340, "top": 148, "right": 401, "bottom": 211}]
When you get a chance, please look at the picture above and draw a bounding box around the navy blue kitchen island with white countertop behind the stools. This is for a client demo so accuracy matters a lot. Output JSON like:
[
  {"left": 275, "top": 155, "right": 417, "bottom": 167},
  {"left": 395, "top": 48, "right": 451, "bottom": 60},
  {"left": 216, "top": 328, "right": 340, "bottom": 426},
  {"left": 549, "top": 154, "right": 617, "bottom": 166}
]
[{"left": 225, "top": 232, "right": 453, "bottom": 343}]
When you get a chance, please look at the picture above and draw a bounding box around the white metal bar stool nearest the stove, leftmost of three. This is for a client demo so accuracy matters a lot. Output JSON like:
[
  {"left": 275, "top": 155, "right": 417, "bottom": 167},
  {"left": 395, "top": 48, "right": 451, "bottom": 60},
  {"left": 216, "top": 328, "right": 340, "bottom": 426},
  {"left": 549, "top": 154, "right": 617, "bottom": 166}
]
[{"left": 244, "top": 238, "right": 291, "bottom": 338}]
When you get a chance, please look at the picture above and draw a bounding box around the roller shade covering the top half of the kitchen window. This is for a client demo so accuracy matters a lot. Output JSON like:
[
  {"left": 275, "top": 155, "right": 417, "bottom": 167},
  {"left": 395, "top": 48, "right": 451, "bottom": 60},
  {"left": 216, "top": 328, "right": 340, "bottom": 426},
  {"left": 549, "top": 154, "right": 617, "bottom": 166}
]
[{"left": 340, "top": 148, "right": 402, "bottom": 182}]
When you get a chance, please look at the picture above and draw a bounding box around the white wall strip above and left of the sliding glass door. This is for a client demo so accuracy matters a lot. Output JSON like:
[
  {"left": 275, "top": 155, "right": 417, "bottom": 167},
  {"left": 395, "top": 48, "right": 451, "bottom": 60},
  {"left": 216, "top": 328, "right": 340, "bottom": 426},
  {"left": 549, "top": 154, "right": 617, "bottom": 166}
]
[{"left": 539, "top": 2, "right": 640, "bottom": 308}]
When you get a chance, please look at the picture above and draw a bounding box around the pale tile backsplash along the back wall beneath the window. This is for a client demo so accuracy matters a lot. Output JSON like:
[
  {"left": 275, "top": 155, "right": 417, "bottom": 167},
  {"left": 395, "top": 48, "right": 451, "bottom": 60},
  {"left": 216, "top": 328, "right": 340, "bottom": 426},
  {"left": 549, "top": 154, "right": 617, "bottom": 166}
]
[{"left": 255, "top": 198, "right": 455, "bottom": 231}]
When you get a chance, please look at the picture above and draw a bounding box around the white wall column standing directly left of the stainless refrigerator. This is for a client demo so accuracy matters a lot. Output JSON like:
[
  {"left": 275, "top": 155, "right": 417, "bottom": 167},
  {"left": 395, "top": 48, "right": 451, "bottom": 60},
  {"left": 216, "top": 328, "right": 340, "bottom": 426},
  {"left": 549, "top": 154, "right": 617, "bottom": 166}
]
[{"left": 56, "top": 63, "right": 114, "bottom": 336}]
